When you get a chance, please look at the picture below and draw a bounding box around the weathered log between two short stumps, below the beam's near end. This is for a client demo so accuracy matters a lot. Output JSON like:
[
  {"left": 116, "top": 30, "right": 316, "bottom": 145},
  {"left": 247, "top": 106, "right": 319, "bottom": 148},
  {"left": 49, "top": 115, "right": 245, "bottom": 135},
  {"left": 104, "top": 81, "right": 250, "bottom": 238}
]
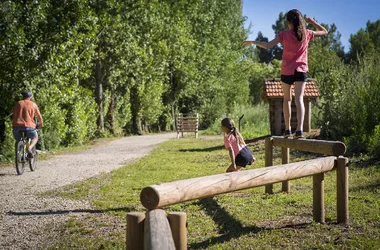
[{"left": 144, "top": 209, "right": 175, "bottom": 250}]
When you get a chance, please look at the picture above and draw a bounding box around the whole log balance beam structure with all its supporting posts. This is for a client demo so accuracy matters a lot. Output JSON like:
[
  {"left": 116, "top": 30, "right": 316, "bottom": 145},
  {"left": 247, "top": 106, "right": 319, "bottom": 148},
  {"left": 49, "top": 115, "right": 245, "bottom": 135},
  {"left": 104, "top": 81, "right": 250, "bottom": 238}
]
[{"left": 127, "top": 137, "right": 348, "bottom": 250}]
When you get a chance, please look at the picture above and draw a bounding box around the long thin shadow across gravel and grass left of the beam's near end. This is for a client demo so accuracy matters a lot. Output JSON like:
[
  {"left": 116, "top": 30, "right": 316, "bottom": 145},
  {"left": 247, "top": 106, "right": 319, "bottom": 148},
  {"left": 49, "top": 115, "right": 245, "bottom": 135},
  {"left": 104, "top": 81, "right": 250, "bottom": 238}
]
[{"left": 7, "top": 207, "right": 136, "bottom": 216}]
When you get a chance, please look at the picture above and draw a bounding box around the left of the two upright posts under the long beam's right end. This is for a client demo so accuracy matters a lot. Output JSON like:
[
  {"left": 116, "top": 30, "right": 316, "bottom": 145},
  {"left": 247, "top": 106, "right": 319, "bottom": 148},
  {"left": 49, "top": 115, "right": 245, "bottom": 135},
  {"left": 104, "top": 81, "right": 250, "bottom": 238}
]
[{"left": 313, "top": 173, "right": 325, "bottom": 223}]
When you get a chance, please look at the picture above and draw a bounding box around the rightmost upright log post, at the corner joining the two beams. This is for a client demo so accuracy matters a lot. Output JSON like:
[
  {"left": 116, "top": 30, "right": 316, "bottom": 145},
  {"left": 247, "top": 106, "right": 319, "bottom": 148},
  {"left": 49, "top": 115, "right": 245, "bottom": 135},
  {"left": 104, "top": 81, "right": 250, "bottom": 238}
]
[{"left": 336, "top": 156, "right": 348, "bottom": 225}]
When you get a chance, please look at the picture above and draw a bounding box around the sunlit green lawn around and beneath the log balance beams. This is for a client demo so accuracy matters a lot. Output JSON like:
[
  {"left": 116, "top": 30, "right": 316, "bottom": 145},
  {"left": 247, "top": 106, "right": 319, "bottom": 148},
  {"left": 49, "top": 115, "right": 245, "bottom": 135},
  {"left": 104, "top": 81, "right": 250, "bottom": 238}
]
[{"left": 41, "top": 138, "right": 380, "bottom": 249}]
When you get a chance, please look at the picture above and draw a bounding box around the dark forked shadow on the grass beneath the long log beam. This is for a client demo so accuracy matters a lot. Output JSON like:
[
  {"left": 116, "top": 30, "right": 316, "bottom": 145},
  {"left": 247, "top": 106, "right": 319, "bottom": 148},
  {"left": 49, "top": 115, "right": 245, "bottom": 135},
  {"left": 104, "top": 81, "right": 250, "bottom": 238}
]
[{"left": 189, "top": 198, "right": 310, "bottom": 249}]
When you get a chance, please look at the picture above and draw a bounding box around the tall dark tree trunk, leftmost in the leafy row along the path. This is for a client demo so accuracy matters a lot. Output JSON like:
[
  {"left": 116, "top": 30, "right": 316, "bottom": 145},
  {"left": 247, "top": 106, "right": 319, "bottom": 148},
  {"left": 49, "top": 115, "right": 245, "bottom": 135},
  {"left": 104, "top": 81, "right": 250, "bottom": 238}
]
[{"left": 95, "top": 45, "right": 104, "bottom": 133}]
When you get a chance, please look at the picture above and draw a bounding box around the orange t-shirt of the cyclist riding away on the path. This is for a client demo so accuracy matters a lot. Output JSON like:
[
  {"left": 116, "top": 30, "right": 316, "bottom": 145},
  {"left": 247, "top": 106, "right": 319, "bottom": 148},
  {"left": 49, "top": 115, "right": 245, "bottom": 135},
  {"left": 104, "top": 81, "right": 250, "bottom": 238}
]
[{"left": 12, "top": 100, "right": 42, "bottom": 128}]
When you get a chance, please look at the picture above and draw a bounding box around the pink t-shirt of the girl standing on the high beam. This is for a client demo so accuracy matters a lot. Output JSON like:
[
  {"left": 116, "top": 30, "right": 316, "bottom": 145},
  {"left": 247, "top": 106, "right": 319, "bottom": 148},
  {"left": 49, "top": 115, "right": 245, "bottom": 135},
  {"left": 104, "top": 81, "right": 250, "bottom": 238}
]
[{"left": 278, "top": 30, "right": 314, "bottom": 75}]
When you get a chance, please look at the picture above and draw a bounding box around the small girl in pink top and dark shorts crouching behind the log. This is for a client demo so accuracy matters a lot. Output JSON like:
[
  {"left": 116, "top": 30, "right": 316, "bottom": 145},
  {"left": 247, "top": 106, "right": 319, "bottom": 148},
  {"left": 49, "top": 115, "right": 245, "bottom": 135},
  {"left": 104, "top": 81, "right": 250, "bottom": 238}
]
[{"left": 221, "top": 118, "right": 256, "bottom": 172}]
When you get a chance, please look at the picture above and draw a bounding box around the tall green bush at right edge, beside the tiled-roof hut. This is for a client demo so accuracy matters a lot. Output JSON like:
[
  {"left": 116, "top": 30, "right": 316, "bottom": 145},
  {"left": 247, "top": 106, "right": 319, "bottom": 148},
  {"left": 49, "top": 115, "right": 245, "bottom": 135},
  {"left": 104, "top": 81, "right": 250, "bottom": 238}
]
[{"left": 319, "top": 53, "right": 380, "bottom": 154}]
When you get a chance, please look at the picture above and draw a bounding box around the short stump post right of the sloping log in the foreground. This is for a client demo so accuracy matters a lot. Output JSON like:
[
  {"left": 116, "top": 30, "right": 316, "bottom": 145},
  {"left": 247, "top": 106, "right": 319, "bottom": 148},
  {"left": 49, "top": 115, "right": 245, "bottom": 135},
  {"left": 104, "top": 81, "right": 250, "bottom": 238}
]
[{"left": 168, "top": 212, "right": 187, "bottom": 250}]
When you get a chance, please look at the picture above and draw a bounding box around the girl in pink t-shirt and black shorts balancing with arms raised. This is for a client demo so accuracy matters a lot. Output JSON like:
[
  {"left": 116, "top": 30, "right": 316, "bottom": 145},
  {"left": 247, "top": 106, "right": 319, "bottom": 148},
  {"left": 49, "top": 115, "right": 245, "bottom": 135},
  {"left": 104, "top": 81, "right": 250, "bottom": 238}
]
[{"left": 243, "top": 9, "right": 328, "bottom": 138}]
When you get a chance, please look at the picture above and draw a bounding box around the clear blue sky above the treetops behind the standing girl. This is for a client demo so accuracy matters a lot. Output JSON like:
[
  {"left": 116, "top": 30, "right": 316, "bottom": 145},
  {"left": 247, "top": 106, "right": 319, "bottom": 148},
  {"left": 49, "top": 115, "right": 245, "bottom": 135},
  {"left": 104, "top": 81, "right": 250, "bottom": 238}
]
[{"left": 243, "top": 0, "right": 380, "bottom": 52}]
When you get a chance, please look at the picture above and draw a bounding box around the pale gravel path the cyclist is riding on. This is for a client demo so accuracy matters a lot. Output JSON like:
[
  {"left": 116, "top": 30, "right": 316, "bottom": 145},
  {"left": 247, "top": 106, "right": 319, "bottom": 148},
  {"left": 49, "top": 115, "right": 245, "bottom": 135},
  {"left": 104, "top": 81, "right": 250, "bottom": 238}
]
[{"left": 0, "top": 133, "right": 176, "bottom": 249}]
